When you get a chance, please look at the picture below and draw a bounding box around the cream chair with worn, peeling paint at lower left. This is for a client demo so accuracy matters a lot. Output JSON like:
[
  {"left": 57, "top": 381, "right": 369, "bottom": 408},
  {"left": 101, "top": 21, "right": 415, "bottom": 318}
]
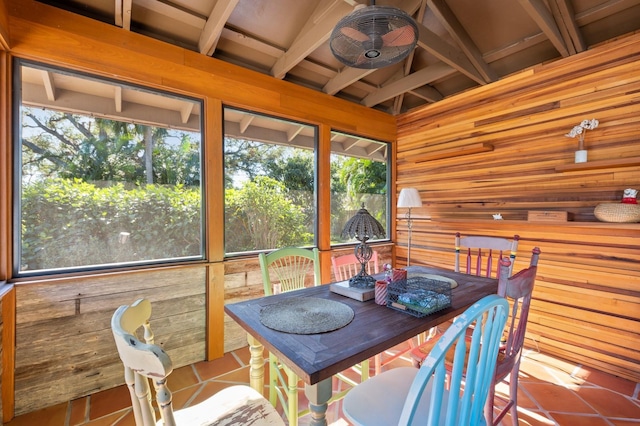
[{"left": 111, "top": 299, "right": 285, "bottom": 426}]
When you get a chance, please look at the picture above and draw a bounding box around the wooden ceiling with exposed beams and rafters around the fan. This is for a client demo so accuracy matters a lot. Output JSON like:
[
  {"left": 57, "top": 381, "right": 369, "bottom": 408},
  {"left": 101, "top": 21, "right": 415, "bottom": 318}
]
[{"left": 33, "top": 0, "right": 640, "bottom": 114}]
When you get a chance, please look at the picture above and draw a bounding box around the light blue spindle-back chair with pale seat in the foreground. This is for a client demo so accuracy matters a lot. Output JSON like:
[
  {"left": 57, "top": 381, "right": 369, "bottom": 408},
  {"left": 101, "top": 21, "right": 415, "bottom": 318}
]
[{"left": 342, "top": 295, "right": 509, "bottom": 426}]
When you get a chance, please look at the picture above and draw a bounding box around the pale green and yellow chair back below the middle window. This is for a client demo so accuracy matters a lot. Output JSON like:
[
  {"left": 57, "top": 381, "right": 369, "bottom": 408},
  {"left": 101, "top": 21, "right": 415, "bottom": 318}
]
[{"left": 258, "top": 247, "right": 321, "bottom": 296}]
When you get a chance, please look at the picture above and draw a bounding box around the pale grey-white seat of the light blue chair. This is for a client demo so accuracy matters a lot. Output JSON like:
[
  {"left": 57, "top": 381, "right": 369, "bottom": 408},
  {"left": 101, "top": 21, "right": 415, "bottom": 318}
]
[{"left": 342, "top": 367, "right": 449, "bottom": 426}]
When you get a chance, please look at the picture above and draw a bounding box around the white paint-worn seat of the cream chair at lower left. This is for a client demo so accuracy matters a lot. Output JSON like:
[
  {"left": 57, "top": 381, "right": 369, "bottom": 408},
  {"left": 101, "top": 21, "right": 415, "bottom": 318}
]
[{"left": 166, "top": 385, "right": 284, "bottom": 426}]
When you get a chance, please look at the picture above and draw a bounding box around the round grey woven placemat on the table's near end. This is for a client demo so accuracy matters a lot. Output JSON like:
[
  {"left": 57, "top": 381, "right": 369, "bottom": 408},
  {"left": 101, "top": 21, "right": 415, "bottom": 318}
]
[{"left": 260, "top": 297, "right": 354, "bottom": 334}]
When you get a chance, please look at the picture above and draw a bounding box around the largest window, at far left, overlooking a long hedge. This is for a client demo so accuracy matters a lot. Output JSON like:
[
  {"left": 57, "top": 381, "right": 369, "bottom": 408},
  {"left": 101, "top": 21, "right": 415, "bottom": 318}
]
[{"left": 14, "top": 62, "right": 204, "bottom": 275}]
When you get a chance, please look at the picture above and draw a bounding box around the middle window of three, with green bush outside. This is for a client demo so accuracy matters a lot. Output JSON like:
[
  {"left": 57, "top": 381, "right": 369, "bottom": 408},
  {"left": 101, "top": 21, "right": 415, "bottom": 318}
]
[{"left": 224, "top": 108, "right": 317, "bottom": 255}]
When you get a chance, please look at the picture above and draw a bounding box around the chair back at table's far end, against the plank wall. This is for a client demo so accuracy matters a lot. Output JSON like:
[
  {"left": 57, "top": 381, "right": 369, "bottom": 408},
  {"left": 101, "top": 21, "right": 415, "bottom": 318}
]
[{"left": 454, "top": 232, "right": 520, "bottom": 278}]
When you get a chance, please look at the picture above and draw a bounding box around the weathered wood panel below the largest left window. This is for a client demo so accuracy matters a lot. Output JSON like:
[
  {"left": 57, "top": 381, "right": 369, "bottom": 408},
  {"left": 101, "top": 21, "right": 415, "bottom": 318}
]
[{"left": 15, "top": 266, "right": 206, "bottom": 414}]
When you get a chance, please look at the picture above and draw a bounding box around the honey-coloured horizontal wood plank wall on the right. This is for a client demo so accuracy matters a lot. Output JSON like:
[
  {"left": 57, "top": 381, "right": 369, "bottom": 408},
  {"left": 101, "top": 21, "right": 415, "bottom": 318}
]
[{"left": 396, "top": 34, "right": 640, "bottom": 382}]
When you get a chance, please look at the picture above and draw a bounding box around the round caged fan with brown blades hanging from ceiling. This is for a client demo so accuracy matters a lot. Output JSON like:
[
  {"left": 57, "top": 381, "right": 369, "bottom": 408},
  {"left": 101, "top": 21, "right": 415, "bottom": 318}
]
[{"left": 329, "top": 1, "right": 418, "bottom": 69}]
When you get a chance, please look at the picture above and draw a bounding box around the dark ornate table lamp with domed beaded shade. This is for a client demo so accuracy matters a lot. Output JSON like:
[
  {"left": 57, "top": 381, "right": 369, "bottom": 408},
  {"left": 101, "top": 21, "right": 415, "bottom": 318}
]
[{"left": 341, "top": 203, "right": 387, "bottom": 288}]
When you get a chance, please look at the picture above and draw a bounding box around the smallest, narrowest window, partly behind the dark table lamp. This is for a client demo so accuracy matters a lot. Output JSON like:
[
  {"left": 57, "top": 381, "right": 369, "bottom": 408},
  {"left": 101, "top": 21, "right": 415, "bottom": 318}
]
[{"left": 331, "top": 131, "right": 390, "bottom": 244}]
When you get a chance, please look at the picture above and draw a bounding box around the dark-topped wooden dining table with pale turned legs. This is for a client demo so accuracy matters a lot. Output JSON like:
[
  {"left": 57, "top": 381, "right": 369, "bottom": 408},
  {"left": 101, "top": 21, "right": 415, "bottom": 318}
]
[{"left": 224, "top": 266, "right": 498, "bottom": 426}]
